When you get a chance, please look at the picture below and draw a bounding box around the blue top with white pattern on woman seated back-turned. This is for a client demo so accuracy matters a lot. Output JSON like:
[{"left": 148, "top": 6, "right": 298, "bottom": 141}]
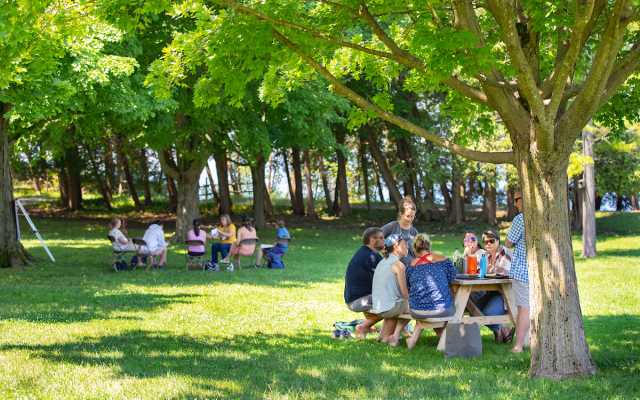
[{"left": 406, "top": 259, "right": 457, "bottom": 311}]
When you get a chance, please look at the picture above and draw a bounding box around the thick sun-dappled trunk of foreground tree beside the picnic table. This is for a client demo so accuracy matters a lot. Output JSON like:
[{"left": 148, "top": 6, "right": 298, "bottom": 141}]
[{"left": 516, "top": 149, "right": 595, "bottom": 379}]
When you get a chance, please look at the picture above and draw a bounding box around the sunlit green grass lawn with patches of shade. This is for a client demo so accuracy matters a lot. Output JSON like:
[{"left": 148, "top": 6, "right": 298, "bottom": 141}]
[{"left": 0, "top": 213, "right": 640, "bottom": 400}]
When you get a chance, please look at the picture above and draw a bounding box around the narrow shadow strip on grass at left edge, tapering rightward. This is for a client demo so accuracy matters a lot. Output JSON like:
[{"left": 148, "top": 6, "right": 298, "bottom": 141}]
[{"left": 0, "top": 288, "right": 197, "bottom": 323}]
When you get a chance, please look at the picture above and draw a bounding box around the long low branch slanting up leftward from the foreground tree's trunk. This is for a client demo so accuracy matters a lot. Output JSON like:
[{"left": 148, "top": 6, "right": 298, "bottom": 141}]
[{"left": 273, "top": 29, "right": 515, "bottom": 164}]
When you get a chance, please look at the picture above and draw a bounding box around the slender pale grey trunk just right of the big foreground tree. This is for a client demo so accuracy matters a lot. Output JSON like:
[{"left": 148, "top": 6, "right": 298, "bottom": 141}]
[{"left": 582, "top": 129, "right": 596, "bottom": 257}]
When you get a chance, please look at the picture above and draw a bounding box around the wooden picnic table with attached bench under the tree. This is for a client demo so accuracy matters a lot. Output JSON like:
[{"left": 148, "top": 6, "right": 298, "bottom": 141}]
[{"left": 400, "top": 278, "right": 516, "bottom": 350}]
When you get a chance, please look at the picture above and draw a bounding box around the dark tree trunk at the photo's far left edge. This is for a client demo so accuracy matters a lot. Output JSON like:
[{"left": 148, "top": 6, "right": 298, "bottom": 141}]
[{"left": 0, "top": 103, "right": 27, "bottom": 268}]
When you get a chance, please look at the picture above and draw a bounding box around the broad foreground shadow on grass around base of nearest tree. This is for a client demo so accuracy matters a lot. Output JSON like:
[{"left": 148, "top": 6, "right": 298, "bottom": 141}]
[{"left": 0, "top": 316, "right": 640, "bottom": 399}]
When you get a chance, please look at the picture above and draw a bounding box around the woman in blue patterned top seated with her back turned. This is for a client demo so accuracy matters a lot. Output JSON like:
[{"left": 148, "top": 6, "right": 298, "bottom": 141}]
[{"left": 407, "top": 233, "right": 457, "bottom": 349}]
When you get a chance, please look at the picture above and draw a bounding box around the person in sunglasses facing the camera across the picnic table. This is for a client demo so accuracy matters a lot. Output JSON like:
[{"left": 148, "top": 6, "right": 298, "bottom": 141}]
[{"left": 471, "top": 230, "right": 515, "bottom": 343}]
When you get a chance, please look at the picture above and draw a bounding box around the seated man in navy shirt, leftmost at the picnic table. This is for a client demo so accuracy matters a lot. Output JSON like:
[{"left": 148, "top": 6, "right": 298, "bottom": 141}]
[{"left": 344, "top": 228, "right": 384, "bottom": 338}]
